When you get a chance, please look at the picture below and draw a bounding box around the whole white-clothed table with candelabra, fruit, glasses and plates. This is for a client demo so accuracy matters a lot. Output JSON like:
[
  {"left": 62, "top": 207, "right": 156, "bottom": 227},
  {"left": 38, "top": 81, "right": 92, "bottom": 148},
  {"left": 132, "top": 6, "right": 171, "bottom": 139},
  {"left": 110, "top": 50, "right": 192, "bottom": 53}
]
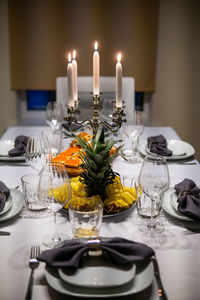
[{"left": 0, "top": 42, "right": 200, "bottom": 300}]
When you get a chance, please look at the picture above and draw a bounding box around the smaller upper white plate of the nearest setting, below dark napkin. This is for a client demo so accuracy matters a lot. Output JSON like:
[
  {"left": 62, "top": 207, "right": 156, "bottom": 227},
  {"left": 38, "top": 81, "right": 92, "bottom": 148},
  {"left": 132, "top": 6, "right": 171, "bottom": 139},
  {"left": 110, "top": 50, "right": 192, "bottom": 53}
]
[{"left": 58, "top": 256, "right": 136, "bottom": 288}]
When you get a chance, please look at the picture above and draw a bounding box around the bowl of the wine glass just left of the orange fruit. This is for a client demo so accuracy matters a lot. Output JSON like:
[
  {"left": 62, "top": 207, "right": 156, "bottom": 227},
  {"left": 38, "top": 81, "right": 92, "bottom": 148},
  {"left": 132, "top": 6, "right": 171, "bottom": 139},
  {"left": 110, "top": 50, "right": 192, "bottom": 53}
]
[{"left": 25, "top": 133, "right": 52, "bottom": 174}]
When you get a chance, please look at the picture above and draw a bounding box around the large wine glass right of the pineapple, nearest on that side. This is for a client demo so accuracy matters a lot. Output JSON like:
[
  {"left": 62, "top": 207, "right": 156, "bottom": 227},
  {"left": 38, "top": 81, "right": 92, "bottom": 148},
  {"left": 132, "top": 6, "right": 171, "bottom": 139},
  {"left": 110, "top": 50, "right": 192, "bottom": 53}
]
[{"left": 137, "top": 156, "right": 169, "bottom": 234}]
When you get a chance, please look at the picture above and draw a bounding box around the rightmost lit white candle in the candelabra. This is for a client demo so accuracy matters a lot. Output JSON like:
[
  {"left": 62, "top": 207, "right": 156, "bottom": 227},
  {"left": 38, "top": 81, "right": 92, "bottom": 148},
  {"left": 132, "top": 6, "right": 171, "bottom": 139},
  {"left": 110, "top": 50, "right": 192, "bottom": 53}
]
[{"left": 116, "top": 53, "right": 122, "bottom": 108}]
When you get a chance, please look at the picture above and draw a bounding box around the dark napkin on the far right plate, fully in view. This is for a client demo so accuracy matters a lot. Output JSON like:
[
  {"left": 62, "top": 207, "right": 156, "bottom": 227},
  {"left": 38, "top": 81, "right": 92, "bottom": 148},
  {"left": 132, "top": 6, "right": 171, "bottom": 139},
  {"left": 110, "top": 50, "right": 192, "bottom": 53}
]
[{"left": 147, "top": 135, "right": 172, "bottom": 156}]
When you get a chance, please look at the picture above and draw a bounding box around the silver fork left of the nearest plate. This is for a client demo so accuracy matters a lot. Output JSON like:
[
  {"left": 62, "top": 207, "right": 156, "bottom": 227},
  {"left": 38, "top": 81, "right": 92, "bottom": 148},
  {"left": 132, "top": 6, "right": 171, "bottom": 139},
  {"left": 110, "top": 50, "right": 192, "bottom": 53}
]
[{"left": 25, "top": 246, "right": 40, "bottom": 300}]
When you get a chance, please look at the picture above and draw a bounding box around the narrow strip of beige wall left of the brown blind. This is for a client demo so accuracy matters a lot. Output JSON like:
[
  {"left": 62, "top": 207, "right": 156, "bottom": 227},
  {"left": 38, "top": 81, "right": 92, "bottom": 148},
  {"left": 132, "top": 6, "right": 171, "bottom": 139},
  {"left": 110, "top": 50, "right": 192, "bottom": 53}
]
[{"left": 0, "top": 0, "right": 17, "bottom": 134}]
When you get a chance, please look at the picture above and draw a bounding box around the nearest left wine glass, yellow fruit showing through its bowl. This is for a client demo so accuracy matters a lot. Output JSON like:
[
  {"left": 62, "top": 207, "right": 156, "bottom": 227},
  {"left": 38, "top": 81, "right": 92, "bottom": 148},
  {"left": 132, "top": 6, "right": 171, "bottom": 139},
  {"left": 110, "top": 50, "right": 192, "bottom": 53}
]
[{"left": 38, "top": 163, "right": 71, "bottom": 248}]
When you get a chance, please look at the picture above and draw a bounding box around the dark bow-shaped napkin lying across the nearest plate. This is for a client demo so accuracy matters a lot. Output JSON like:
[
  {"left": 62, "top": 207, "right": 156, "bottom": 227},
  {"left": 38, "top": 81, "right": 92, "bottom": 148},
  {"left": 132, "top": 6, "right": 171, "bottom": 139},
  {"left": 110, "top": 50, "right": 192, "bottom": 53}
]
[{"left": 38, "top": 237, "right": 154, "bottom": 269}]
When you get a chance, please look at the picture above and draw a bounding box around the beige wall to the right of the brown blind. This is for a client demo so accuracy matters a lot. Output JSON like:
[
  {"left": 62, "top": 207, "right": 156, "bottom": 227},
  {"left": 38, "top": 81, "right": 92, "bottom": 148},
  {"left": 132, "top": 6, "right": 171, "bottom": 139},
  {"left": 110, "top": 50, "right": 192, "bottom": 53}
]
[{"left": 153, "top": 0, "right": 200, "bottom": 159}]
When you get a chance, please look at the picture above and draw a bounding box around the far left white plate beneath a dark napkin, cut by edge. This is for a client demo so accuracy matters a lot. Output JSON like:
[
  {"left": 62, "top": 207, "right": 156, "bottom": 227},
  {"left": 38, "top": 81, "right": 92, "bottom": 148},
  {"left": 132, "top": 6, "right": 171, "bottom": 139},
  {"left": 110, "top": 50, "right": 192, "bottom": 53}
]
[{"left": 0, "top": 140, "right": 25, "bottom": 161}]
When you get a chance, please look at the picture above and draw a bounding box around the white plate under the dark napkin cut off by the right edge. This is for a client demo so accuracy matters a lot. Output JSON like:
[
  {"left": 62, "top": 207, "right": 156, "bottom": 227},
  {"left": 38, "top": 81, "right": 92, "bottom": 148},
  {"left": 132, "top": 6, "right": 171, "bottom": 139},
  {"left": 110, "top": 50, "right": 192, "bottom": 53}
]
[{"left": 163, "top": 188, "right": 194, "bottom": 222}]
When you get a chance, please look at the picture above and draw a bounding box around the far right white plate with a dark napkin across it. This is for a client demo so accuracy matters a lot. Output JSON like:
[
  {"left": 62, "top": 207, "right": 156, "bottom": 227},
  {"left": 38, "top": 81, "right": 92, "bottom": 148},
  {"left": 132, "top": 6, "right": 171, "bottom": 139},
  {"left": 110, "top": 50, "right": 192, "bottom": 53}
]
[{"left": 138, "top": 140, "right": 195, "bottom": 160}]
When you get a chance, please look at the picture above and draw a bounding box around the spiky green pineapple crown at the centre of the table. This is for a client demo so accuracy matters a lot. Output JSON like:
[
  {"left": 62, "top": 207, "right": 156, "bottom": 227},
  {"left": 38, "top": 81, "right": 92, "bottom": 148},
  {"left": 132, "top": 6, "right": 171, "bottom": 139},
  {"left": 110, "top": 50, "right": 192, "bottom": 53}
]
[{"left": 76, "top": 129, "right": 121, "bottom": 201}]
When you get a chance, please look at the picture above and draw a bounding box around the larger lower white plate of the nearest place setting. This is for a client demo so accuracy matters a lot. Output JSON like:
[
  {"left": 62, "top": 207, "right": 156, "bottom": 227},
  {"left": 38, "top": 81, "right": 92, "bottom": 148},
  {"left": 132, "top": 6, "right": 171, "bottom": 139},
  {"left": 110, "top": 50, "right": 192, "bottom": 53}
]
[{"left": 45, "top": 263, "right": 153, "bottom": 298}]
